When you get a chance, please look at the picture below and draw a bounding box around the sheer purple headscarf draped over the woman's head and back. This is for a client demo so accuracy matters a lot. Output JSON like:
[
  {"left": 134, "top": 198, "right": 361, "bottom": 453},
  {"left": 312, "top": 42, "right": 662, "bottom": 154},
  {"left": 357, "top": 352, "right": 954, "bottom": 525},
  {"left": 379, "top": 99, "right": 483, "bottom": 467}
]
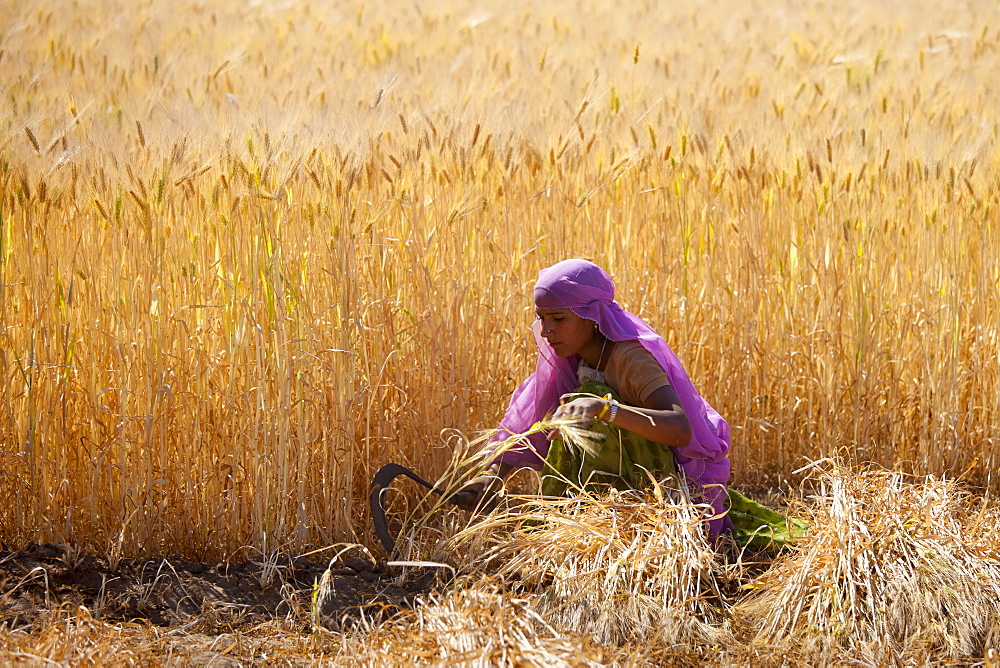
[{"left": 493, "top": 260, "right": 732, "bottom": 535}]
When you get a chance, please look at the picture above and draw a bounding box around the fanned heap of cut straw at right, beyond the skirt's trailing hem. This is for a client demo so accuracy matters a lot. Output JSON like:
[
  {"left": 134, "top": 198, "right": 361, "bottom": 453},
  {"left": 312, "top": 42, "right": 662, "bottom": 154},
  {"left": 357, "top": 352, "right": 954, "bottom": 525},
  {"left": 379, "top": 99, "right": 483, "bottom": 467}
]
[{"left": 734, "top": 467, "right": 1000, "bottom": 664}]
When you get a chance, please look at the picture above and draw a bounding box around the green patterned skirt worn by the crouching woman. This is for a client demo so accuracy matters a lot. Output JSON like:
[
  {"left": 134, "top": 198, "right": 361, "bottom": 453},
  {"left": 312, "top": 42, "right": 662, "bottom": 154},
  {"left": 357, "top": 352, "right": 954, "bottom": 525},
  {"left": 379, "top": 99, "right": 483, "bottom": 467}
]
[{"left": 541, "top": 380, "right": 807, "bottom": 552}]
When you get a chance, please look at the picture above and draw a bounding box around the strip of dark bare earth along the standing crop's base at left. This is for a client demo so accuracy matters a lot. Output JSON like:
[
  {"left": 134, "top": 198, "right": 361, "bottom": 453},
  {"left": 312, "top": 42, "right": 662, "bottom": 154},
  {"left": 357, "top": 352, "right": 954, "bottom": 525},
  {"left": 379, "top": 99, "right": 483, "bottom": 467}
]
[{"left": 0, "top": 544, "right": 436, "bottom": 630}]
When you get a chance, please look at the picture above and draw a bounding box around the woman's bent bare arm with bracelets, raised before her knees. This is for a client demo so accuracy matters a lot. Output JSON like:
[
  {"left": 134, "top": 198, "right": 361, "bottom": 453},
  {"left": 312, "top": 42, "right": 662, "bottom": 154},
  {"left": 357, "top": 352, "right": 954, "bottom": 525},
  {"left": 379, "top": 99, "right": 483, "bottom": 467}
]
[{"left": 551, "top": 385, "right": 691, "bottom": 447}]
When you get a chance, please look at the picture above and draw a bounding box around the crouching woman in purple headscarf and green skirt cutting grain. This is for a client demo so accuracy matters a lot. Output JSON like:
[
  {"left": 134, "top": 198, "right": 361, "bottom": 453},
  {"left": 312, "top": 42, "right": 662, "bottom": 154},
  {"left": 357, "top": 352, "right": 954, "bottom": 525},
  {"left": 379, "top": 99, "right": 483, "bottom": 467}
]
[{"left": 462, "top": 260, "right": 787, "bottom": 542}]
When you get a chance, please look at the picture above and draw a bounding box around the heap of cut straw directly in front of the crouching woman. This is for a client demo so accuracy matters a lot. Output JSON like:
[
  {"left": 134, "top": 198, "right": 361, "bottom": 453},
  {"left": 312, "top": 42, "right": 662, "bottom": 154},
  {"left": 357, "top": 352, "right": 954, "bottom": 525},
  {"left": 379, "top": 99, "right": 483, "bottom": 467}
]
[{"left": 453, "top": 486, "right": 728, "bottom": 651}]
